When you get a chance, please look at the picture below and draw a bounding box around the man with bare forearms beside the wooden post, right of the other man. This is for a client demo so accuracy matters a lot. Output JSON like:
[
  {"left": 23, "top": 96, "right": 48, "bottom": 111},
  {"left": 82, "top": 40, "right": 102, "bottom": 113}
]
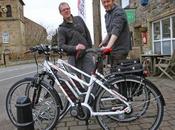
[{"left": 99, "top": 0, "right": 131, "bottom": 67}]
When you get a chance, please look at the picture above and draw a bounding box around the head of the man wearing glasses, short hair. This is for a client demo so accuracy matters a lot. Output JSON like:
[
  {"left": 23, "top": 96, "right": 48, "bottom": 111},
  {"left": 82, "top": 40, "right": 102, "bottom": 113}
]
[{"left": 58, "top": 2, "right": 71, "bottom": 19}]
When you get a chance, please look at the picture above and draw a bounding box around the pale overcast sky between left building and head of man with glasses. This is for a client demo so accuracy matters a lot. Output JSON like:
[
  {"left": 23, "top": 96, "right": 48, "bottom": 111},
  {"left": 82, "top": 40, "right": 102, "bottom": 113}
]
[{"left": 23, "top": 0, "right": 77, "bottom": 30}]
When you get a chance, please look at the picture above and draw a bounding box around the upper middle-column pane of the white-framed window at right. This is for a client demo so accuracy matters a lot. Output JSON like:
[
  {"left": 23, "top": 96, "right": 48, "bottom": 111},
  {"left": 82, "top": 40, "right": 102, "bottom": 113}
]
[{"left": 162, "top": 18, "right": 170, "bottom": 38}]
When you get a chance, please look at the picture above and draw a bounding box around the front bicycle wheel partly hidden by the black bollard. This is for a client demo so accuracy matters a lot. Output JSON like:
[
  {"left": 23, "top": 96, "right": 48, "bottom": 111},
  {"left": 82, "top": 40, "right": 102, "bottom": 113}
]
[{"left": 6, "top": 78, "right": 60, "bottom": 130}]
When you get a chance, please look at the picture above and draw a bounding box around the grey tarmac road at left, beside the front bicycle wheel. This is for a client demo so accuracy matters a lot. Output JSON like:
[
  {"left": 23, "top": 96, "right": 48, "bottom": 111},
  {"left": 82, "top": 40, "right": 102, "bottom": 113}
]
[{"left": 0, "top": 64, "right": 36, "bottom": 130}]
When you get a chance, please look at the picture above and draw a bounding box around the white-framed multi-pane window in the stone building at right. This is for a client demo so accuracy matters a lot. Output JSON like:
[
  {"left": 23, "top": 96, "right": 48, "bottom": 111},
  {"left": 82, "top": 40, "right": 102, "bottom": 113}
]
[{"left": 152, "top": 16, "right": 175, "bottom": 54}]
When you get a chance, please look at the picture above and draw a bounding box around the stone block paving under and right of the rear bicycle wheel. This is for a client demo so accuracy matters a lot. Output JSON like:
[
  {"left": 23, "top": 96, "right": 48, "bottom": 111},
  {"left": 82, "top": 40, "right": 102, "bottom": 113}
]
[{"left": 54, "top": 77, "right": 175, "bottom": 130}]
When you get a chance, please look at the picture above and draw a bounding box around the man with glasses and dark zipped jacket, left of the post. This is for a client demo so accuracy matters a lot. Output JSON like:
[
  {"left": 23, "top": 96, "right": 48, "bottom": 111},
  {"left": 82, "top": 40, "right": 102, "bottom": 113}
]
[{"left": 58, "top": 2, "right": 94, "bottom": 78}]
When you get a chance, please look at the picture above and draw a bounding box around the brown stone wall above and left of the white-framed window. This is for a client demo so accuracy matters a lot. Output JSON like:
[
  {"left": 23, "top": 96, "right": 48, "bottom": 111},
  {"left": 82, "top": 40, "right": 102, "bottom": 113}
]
[{"left": 129, "top": 0, "right": 175, "bottom": 52}]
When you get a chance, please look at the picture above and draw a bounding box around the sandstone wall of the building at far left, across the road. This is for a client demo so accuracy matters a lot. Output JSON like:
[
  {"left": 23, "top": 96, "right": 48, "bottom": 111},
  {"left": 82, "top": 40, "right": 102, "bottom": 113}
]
[{"left": 0, "top": 0, "right": 47, "bottom": 60}]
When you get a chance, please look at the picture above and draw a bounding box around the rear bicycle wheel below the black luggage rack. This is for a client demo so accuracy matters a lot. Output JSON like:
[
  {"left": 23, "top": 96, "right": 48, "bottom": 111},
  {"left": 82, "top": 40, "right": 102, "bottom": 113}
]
[{"left": 95, "top": 76, "right": 164, "bottom": 130}]
